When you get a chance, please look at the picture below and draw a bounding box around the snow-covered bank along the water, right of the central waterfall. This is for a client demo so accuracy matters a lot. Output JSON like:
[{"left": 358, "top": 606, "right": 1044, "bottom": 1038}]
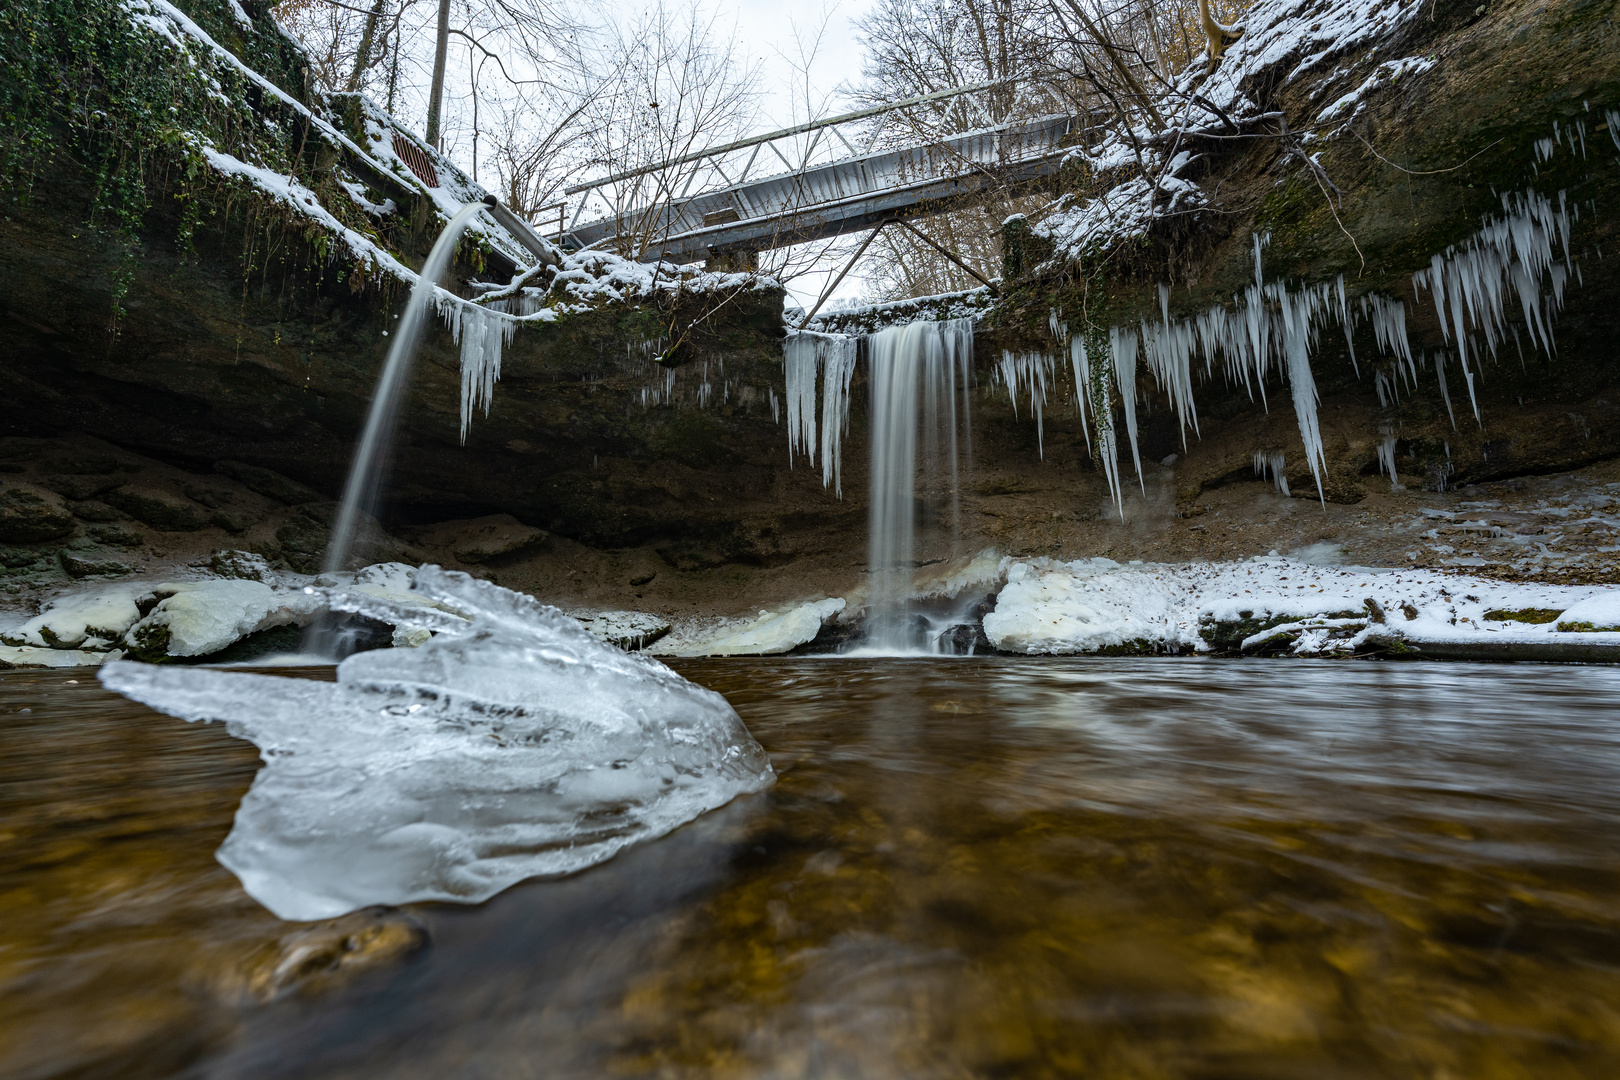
[{"left": 985, "top": 555, "right": 1620, "bottom": 661}]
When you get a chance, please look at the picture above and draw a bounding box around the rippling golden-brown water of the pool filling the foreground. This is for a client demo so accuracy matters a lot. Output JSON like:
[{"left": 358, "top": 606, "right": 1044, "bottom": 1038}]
[{"left": 0, "top": 659, "right": 1620, "bottom": 1080}]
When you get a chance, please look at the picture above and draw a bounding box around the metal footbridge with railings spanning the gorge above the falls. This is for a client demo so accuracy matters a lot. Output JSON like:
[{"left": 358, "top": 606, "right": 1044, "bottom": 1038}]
[{"left": 552, "top": 81, "right": 1079, "bottom": 262}]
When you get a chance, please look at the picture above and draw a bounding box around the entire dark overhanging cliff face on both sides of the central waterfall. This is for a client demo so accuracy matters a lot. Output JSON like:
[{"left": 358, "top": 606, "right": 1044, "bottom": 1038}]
[{"left": 0, "top": 0, "right": 1620, "bottom": 606}]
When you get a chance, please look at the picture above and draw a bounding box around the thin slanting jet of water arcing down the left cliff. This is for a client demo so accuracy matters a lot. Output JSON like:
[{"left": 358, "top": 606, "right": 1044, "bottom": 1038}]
[{"left": 322, "top": 202, "right": 484, "bottom": 573}]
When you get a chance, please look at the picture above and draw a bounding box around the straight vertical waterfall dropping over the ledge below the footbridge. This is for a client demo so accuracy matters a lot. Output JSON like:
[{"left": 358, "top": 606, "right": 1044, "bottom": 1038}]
[{"left": 867, "top": 319, "right": 974, "bottom": 653}]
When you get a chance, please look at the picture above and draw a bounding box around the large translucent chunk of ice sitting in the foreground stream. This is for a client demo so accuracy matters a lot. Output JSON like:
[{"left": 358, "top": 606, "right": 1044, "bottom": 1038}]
[{"left": 102, "top": 567, "right": 774, "bottom": 920}]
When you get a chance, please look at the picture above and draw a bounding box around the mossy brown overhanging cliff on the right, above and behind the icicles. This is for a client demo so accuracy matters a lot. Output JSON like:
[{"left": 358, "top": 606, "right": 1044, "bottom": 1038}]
[{"left": 1000, "top": 0, "right": 1620, "bottom": 502}]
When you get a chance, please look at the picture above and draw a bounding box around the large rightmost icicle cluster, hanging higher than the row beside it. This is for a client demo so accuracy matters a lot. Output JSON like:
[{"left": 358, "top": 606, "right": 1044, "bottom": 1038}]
[{"left": 1413, "top": 191, "right": 1576, "bottom": 426}]
